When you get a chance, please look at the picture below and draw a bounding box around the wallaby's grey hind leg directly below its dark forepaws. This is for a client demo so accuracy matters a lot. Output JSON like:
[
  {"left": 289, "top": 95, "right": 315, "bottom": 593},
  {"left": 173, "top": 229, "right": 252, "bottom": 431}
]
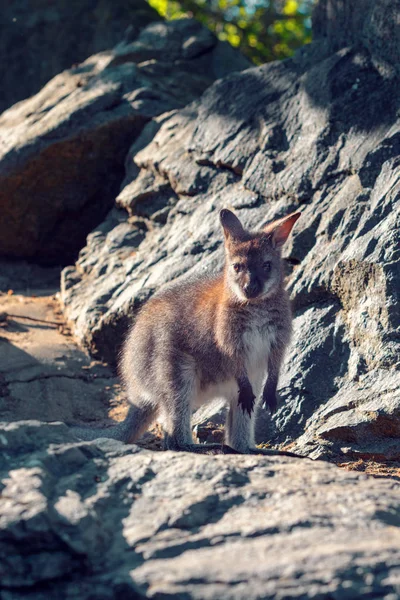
[{"left": 225, "top": 398, "right": 256, "bottom": 454}]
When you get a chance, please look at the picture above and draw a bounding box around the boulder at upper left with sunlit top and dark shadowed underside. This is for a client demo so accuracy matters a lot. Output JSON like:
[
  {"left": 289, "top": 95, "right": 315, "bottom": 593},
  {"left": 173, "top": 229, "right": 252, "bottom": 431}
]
[{"left": 0, "top": 19, "right": 248, "bottom": 265}]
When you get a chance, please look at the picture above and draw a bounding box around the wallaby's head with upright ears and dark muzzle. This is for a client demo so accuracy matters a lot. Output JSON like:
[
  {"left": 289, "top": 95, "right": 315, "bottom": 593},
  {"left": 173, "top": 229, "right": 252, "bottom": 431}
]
[{"left": 220, "top": 209, "right": 300, "bottom": 302}]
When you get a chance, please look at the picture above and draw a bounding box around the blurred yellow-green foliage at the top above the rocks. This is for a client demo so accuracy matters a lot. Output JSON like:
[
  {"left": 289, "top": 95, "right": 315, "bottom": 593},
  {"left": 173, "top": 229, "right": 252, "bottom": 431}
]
[{"left": 148, "top": 0, "right": 314, "bottom": 64}]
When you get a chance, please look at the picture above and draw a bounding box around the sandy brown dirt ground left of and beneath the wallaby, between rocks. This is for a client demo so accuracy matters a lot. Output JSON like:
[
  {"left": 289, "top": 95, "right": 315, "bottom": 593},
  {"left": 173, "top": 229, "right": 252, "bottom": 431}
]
[{"left": 0, "top": 268, "right": 400, "bottom": 480}]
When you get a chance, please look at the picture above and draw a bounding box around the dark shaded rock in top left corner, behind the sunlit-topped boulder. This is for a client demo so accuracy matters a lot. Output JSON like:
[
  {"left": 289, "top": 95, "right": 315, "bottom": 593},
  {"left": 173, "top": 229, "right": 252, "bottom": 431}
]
[{"left": 0, "top": 0, "right": 159, "bottom": 112}]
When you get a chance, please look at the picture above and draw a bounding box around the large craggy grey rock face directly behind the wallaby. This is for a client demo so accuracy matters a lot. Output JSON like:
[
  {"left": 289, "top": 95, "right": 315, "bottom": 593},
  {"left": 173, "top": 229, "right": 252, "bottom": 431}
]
[{"left": 62, "top": 0, "right": 400, "bottom": 460}]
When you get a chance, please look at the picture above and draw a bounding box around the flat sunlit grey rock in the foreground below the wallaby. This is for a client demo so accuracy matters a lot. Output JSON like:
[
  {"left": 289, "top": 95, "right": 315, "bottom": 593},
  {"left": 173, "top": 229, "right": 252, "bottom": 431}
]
[{"left": 0, "top": 421, "right": 400, "bottom": 600}]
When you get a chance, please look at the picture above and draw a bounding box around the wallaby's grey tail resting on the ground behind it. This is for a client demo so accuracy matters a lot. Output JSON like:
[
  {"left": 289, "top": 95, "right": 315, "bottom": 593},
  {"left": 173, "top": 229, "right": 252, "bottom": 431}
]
[{"left": 70, "top": 406, "right": 155, "bottom": 444}]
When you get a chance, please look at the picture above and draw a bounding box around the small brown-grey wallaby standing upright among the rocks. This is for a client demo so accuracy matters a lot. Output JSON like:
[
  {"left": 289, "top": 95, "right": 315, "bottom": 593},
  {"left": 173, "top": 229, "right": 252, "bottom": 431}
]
[{"left": 75, "top": 209, "right": 300, "bottom": 454}]
